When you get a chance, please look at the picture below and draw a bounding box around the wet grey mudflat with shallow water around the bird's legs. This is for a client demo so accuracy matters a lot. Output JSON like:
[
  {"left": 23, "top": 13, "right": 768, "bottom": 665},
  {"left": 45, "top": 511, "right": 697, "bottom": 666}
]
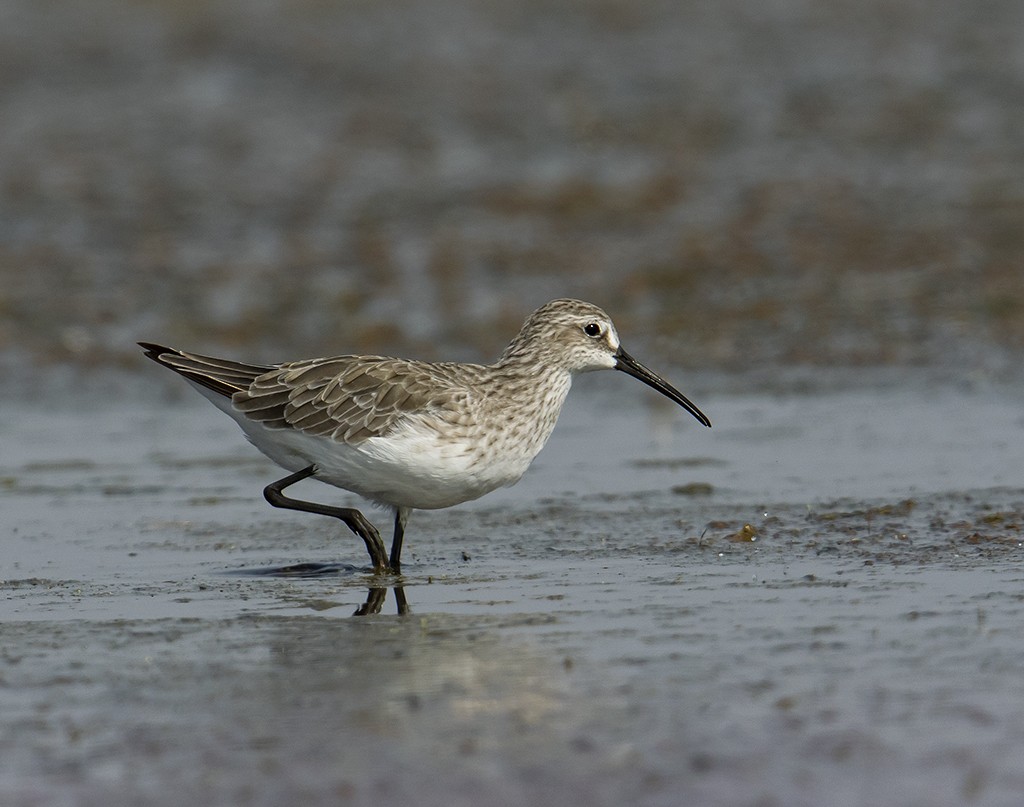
[{"left": 0, "top": 379, "right": 1024, "bottom": 805}]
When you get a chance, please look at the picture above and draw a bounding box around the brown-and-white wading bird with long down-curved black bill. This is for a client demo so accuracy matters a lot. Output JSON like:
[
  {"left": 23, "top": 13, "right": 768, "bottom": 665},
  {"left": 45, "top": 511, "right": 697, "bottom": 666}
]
[{"left": 139, "top": 299, "right": 711, "bottom": 574}]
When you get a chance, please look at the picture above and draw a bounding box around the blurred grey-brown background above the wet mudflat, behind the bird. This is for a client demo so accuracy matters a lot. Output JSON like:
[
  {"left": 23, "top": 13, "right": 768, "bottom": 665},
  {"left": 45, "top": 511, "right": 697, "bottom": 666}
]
[{"left": 0, "top": 0, "right": 1024, "bottom": 392}]
